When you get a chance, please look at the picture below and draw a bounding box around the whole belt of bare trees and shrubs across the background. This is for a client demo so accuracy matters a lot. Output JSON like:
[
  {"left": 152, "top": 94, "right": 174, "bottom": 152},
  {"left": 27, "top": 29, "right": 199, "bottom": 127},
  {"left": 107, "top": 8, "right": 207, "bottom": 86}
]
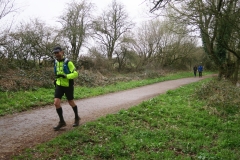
[{"left": 0, "top": 0, "right": 240, "bottom": 90}]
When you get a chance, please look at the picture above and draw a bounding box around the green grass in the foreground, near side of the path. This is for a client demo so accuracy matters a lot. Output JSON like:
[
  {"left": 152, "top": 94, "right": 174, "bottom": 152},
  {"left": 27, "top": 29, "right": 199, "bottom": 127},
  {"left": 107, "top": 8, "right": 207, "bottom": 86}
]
[{"left": 13, "top": 79, "right": 240, "bottom": 160}]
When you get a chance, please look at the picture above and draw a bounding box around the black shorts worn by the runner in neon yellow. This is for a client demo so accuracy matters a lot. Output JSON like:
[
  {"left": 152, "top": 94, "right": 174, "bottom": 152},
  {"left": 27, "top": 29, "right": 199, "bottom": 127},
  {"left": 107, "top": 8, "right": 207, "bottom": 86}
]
[{"left": 54, "top": 85, "right": 74, "bottom": 100}]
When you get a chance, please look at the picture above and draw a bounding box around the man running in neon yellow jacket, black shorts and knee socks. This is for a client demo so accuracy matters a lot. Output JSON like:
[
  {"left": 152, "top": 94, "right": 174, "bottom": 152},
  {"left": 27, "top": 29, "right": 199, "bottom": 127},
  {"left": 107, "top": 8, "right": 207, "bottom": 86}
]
[{"left": 53, "top": 46, "right": 80, "bottom": 131}]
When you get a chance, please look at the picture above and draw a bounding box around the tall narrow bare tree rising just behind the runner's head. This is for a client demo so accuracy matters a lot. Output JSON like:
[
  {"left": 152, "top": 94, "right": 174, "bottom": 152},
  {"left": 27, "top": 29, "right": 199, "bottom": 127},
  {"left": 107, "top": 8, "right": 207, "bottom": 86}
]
[{"left": 59, "top": 0, "right": 92, "bottom": 61}]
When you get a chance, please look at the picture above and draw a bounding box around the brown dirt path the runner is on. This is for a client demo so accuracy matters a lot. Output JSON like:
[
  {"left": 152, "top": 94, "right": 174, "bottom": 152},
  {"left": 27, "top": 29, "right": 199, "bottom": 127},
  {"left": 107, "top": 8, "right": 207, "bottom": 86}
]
[{"left": 0, "top": 77, "right": 211, "bottom": 159}]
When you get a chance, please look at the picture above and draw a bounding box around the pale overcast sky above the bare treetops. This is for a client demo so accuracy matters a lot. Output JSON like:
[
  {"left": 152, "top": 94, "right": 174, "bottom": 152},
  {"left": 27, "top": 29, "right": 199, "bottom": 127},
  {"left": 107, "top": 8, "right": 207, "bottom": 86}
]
[{"left": 10, "top": 0, "right": 152, "bottom": 26}]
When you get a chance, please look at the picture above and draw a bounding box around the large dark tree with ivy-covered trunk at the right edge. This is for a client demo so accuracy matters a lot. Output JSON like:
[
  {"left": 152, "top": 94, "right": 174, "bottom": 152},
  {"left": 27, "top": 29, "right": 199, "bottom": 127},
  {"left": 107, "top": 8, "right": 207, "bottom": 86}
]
[{"left": 149, "top": 0, "right": 240, "bottom": 81}]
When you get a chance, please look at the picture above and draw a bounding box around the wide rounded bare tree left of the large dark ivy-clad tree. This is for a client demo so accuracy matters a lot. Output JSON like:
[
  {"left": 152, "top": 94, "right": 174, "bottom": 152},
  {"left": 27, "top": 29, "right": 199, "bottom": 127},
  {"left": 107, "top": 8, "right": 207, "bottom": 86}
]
[{"left": 135, "top": 19, "right": 196, "bottom": 67}]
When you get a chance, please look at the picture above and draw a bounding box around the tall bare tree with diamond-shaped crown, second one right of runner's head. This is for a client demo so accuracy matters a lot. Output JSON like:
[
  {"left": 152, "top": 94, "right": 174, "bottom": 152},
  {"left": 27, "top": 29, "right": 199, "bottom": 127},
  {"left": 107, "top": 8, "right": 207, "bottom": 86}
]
[{"left": 93, "top": 0, "right": 133, "bottom": 60}]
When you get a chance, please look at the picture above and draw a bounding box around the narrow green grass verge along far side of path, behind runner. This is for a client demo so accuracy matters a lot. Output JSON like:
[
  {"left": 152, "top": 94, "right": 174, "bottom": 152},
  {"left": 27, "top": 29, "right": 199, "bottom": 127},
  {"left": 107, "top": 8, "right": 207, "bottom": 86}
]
[{"left": 0, "top": 72, "right": 214, "bottom": 116}]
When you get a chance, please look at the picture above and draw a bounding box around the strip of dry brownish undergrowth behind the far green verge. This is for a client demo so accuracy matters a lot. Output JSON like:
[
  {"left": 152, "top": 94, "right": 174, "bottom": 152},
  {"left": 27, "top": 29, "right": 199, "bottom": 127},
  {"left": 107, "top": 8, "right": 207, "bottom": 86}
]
[{"left": 0, "top": 67, "right": 169, "bottom": 92}]
